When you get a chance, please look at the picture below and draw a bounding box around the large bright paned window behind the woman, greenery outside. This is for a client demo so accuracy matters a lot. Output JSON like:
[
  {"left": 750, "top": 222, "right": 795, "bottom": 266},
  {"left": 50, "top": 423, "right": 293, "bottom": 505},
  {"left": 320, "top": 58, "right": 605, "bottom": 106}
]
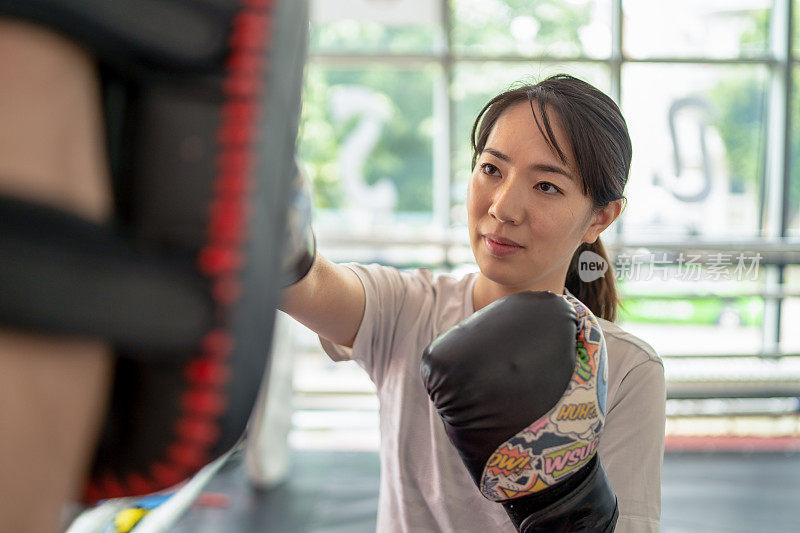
[{"left": 299, "top": 0, "right": 800, "bottom": 444}]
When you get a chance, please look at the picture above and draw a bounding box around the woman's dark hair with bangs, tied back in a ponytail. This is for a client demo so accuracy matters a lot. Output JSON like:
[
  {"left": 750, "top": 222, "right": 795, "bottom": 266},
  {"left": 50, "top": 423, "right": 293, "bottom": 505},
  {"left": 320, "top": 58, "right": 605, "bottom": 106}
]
[{"left": 472, "top": 74, "right": 632, "bottom": 322}]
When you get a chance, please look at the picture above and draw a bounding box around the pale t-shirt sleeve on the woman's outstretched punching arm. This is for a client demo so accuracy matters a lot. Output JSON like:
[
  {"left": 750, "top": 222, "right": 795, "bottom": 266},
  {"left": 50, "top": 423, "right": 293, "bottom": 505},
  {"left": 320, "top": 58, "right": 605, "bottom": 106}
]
[{"left": 320, "top": 263, "right": 432, "bottom": 387}]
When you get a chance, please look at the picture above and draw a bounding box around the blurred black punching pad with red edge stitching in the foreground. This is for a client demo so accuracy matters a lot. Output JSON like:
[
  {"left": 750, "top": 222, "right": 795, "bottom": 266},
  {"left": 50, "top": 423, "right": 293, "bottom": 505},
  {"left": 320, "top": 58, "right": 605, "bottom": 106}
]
[{"left": 0, "top": 0, "right": 307, "bottom": 501}]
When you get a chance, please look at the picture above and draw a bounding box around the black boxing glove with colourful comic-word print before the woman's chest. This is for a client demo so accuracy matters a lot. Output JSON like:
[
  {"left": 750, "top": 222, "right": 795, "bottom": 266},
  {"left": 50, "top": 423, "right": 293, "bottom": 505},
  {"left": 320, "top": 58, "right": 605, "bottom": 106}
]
[{"left": 421, "top": 291, "right": 618, "bottom": 533}]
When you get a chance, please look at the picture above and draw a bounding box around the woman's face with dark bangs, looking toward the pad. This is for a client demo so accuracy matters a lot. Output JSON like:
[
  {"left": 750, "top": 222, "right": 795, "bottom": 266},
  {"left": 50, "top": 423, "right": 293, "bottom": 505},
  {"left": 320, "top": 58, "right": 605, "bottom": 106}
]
[{"left": 467, "top": 101, "right": 616, "bottom": 291}]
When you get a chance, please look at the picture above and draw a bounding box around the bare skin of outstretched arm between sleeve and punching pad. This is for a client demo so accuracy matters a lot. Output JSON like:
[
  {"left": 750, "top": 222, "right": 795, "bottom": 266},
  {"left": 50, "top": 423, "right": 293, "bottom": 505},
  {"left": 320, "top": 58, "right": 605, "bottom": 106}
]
[{"left": 279, "top": 252, "right": 366, "bottom": 348}]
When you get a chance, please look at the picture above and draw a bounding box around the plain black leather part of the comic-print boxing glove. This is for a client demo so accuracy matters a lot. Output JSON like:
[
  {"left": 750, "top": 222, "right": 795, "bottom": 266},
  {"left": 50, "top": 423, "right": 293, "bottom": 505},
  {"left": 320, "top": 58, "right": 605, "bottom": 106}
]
[{"left": 421, "top": 291, "right": 578, "bottom": 483}]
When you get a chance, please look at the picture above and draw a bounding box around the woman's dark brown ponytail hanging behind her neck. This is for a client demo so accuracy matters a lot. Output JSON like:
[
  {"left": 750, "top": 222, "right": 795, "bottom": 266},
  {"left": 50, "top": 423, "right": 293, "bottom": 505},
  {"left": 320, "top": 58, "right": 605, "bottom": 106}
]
[{"left": 565, "top": 237, "right": 620, "bottom": 322}]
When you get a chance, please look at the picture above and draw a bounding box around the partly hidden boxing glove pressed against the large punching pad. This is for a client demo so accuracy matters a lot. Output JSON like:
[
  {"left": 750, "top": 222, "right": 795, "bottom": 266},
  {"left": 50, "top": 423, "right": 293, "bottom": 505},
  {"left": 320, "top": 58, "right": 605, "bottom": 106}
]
[{"left": 281, "top": 165, "right": 317, "bottom": 288}]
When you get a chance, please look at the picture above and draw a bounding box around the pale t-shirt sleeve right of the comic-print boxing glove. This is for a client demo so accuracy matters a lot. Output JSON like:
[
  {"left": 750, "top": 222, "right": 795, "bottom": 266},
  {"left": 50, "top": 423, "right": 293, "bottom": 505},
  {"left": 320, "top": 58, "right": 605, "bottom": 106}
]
[{"left": 600, "top": 359, "right": 666, "bottom": 533}]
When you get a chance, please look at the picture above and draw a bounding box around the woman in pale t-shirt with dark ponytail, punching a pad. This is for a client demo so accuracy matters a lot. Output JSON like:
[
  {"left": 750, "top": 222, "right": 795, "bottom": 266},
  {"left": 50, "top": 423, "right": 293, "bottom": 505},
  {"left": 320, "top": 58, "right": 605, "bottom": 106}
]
[{"left": 282, "top": 75, "right": 665, "bottom": 533}]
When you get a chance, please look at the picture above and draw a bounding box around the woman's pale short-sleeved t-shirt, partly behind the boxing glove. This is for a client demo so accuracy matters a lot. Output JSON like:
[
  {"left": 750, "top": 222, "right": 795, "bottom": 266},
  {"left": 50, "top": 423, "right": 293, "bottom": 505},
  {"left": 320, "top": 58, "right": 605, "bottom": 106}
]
[{"left": 320, "top": 263, "right": 665, "bottom": 533}]
